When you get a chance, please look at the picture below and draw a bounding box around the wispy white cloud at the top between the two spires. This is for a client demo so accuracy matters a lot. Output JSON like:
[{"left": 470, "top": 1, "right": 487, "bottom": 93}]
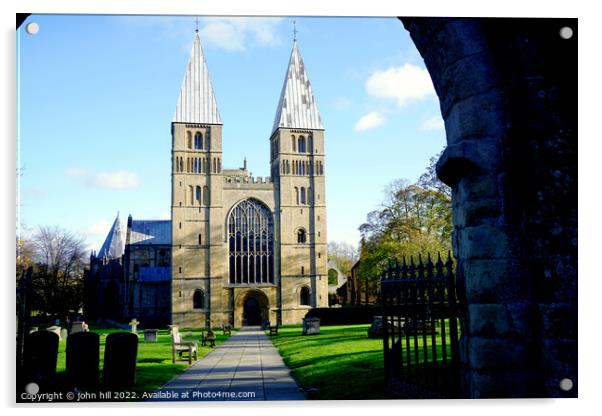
[{"left": 199, "top": 17, "right": 282, "bottom": 51}]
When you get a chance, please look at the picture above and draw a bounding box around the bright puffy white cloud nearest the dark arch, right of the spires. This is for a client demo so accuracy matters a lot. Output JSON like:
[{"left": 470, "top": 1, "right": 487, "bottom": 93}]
[{"left": 365, "top": 64, "right": 435, "bottom": 107}]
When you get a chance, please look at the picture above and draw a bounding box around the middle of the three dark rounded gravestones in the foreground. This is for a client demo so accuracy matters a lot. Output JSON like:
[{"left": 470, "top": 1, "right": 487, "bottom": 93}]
[{"left": 66, "top": 332, "right": 100, "bottom": 390}]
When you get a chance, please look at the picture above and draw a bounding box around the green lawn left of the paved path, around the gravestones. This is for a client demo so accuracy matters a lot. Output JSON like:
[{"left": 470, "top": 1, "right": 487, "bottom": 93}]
[{"left": 57, "top": 328, "right": 234, "bottom": 393}]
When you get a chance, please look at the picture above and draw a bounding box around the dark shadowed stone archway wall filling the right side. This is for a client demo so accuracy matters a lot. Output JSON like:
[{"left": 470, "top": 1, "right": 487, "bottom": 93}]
[{"left": 401, "top": 18, "right": 577, "bottom": 397}]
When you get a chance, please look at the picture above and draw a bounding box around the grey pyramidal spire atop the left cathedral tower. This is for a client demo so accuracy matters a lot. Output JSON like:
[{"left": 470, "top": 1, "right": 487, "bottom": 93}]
[{"left": 172, "top": 31, "right": 222, "bottom": 124}]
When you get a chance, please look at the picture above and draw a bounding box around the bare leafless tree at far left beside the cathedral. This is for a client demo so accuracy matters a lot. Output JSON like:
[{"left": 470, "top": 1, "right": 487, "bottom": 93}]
[{"left": 26, "top": 226, "right": 87, "bottom": 316}]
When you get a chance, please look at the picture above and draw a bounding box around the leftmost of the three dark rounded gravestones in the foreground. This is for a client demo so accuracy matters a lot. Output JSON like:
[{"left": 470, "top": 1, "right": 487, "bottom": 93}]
[{"left": 24, "top": 331, "right": 59, "bottom": 386}]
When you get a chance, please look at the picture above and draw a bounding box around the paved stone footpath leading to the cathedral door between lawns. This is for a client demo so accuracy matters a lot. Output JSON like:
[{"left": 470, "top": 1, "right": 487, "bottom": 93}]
[{"left": 148, "top": 327, "right": 305, "bottom": 401}]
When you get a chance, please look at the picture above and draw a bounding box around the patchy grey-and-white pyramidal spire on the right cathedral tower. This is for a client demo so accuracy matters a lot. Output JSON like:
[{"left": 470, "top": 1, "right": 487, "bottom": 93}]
[{"left": 272, "top": 40, "right": 324, "bottom": 132}]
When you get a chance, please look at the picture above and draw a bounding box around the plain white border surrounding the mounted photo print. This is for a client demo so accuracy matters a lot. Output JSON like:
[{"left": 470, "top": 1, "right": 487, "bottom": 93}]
[{"left": 0, "top": 0, "right": 602, "bottom": 416}]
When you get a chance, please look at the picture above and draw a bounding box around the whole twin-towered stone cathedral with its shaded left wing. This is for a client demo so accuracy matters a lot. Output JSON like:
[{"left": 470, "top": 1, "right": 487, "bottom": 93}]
[{"left": 84, "top": 31, "right": 328, "bottom": 327}]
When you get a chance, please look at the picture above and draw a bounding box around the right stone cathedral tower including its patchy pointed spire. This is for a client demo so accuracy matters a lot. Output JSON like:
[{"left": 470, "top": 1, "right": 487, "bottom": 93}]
[{"left": 270, "top": 40, "right": 328, "bottom": 323}]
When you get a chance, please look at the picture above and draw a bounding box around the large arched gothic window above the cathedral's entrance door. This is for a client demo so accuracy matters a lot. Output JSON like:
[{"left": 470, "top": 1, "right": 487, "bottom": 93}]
[{"left": 228, "top": 198, "right": 274, "bottom": 284}]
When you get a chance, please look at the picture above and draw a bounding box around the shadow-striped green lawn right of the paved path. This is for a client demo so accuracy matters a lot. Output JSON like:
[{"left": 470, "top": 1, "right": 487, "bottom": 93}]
[{"left": 271, "top": 325, "right": 388, "bottom": 400}]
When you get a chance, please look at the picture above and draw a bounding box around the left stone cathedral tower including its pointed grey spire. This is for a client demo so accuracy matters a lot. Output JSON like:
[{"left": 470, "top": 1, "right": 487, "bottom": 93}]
[{"left": 171, "top": 31, "right": 224, "bottom": 327}]
